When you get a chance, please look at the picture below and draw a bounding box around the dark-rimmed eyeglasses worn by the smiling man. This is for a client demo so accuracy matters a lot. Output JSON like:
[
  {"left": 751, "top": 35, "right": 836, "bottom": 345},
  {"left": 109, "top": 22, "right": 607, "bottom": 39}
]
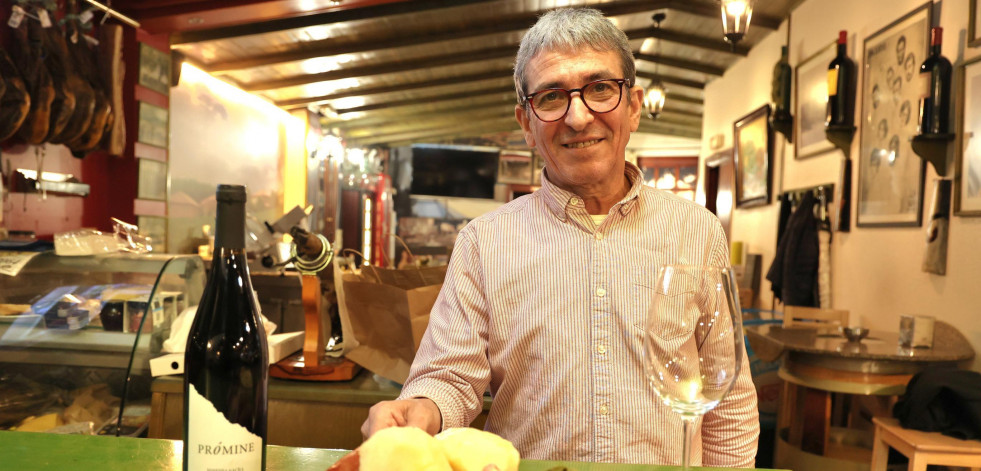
[{"left": 525, "top": 79, "right": 630, "bottom": 123}]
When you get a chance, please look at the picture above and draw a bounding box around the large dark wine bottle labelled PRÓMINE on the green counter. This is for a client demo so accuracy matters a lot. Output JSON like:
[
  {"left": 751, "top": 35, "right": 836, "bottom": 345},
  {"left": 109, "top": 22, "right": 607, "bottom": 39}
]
[{"left": 184, "top": 185, "right": 269, "bottom": 471}]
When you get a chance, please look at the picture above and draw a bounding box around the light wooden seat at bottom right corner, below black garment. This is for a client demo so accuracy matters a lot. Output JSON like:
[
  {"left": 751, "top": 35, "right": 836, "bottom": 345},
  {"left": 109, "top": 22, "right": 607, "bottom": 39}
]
[{"left": 869, "top": 417, "right": 981, "bottom": 471}]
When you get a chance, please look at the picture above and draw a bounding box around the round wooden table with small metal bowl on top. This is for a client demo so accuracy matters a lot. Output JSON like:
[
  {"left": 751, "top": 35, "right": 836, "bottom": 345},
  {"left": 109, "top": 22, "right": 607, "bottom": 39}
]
[{"left": 746, "top": 321, "right": 974, "bottom": 471}]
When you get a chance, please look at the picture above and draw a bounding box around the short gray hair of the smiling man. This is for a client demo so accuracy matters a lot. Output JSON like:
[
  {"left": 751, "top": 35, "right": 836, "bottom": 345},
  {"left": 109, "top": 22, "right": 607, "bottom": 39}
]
[{"left": 514, "top": 8, "right": 636, "bottom": 103}]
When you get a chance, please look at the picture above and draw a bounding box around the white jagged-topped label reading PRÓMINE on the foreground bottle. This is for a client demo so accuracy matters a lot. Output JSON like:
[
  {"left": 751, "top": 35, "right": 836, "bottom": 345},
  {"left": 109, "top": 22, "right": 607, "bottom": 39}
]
[{"left": 184, "top": 384, "right": 262, "bottom": 471}]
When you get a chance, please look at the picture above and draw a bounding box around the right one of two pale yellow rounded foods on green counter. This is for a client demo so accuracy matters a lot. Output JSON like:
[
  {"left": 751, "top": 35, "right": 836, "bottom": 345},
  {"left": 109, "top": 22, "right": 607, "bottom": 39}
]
[{"left": 436, "top": 427, "right": 521, "bottom": 471}]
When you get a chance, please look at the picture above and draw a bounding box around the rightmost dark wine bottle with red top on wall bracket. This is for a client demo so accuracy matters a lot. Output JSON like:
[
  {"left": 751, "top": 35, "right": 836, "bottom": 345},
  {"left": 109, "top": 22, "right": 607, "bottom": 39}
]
[{"left": 919, "top": 27, "right": 951, "bottom": 134}]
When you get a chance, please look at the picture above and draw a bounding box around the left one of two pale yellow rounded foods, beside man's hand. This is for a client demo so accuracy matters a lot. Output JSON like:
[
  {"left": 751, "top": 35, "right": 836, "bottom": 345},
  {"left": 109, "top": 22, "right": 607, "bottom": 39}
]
[{"left": 358, "top": 427, "right": 452, "bottom": 471}]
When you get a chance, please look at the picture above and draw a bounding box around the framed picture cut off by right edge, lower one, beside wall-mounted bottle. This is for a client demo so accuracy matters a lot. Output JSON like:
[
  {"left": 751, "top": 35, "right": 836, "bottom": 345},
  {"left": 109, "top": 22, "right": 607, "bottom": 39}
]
[{"left": 954, "top": 58, "right": 981, "bottom": 216}]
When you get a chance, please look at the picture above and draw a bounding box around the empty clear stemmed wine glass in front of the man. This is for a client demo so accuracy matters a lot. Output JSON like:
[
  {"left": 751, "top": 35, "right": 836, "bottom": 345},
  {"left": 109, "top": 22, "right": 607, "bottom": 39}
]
[{"left": 644, "top": 265, "right": 744, "bottom": 471}]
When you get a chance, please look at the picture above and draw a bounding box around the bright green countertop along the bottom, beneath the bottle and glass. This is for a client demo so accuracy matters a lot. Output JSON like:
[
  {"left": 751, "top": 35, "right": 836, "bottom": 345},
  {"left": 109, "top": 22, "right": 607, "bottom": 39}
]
[{"left": 0, "top": 431, "right": 780, "bottom": 471}]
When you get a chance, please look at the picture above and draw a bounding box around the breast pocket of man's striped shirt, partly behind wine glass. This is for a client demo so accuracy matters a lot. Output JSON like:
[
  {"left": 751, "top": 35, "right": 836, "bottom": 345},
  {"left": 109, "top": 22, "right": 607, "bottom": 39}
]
[{"left": 633, "top": 266, "right": 699, "bottom": 340}]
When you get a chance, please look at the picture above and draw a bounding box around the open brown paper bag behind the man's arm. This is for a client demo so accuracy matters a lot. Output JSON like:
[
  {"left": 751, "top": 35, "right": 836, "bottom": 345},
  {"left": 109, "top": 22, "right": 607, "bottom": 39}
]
[{"left": 334, "top": 258, "right": 446, "bottom": 384}]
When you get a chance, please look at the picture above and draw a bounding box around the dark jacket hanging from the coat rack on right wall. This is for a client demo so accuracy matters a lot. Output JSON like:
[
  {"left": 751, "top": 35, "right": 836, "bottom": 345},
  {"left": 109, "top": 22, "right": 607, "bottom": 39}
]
[{"left": 766, "top": 191, "right": 820, "bottom": 307}]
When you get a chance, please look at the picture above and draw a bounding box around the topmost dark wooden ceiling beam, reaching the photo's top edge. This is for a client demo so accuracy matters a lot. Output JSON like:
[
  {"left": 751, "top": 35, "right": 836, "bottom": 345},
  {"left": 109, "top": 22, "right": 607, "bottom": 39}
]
[{"left": 170, "top": 0, "right": 502, "bottom": 45}]
